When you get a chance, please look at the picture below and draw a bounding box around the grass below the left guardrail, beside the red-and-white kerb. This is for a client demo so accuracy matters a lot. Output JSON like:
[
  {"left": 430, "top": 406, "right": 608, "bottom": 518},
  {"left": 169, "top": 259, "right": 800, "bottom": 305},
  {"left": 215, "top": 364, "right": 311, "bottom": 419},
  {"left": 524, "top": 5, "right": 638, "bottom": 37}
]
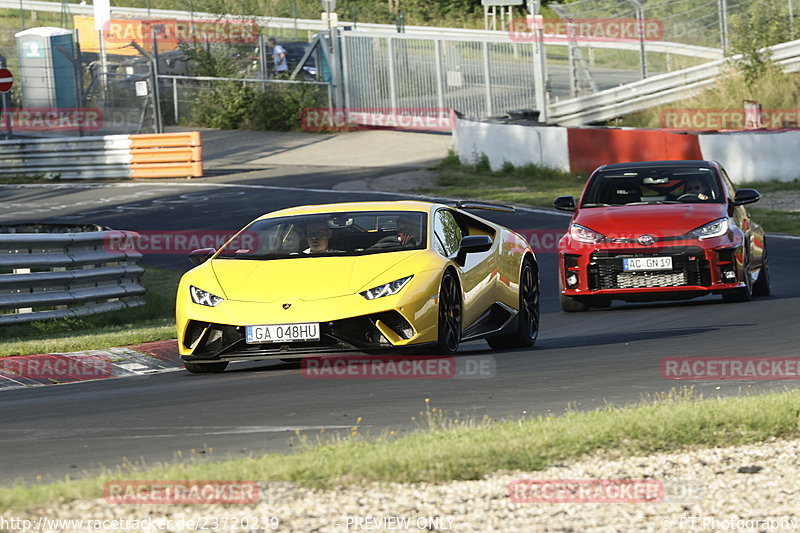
[{"left": 0, "top": 268, "right": 181, "bottom": 357}]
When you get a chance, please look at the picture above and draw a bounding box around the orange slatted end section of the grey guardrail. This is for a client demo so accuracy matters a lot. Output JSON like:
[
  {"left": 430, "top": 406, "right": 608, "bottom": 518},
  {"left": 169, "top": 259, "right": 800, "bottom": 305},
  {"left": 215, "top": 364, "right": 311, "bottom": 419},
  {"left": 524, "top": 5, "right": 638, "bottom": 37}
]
[{"left": 128, "top": 131, "right": 203, "bottom": 178}]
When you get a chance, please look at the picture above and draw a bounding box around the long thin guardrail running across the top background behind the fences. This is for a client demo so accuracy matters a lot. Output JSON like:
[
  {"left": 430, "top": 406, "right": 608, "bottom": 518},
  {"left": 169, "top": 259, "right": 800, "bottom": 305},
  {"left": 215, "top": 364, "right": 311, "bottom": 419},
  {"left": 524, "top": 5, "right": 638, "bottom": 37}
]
[{"left": 7, "top": 0, "right": 722, "bottom": 59}]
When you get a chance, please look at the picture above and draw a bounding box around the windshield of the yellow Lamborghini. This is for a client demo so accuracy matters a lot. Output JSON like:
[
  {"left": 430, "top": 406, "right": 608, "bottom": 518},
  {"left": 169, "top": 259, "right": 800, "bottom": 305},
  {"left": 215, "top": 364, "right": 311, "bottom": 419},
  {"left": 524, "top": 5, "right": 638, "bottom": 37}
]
[{"left": 217, "top": 211, "right": 427, "bottom": 259}]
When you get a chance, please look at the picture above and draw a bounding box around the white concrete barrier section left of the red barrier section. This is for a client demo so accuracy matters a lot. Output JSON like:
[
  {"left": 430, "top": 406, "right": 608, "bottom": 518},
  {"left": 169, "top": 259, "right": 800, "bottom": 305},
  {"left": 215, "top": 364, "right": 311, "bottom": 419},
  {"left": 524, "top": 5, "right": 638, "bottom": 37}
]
[{"left": 453, "top": 118, "right": 569, "bottom": 171}]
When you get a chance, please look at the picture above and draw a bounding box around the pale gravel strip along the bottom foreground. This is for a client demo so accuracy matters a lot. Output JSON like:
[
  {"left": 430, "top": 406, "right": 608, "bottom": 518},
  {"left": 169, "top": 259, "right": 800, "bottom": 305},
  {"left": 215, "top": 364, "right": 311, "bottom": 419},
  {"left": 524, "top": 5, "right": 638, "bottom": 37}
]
[{"left": 0, "top": 439, "right": 800, "bottom": 533}]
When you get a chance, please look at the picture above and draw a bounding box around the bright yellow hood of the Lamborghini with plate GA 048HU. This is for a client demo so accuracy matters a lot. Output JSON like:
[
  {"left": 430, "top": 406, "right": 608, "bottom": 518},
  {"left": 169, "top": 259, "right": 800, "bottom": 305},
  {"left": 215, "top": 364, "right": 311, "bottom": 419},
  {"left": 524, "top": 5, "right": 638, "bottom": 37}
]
[{"left": 211, "top": 250, "right": 425, "bottom": 302}]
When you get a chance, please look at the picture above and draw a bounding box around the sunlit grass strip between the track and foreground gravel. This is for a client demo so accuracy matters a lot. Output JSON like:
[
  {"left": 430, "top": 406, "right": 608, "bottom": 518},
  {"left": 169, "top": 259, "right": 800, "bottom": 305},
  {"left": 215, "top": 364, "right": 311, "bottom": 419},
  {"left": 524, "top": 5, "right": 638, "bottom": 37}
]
[{"left": 0, "top": 389, "right": 800, "bottom": 512}]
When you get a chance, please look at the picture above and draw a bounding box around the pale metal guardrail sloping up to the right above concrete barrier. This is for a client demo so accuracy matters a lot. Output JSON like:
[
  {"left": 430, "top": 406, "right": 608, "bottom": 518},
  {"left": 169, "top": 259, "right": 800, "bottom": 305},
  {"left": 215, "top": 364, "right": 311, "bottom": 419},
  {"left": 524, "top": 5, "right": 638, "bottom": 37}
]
[{"left": 549, "top": 40, "right": 800, "bottom": 126}]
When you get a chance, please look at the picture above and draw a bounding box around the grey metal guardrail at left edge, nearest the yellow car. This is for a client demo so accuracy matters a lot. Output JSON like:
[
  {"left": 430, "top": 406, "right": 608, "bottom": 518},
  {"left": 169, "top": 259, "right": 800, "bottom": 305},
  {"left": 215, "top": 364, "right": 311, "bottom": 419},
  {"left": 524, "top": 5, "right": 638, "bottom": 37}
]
[{"left": 0, "top": 225, "right": 145, "bottom": 324}]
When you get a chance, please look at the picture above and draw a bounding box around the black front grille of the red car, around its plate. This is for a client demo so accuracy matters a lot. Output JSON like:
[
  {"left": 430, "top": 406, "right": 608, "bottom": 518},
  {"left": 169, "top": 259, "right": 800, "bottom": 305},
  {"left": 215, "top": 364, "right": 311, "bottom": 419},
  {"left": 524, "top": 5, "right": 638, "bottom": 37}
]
[{"left": 589, "top": 247, "right": 711, "bottom": 290}]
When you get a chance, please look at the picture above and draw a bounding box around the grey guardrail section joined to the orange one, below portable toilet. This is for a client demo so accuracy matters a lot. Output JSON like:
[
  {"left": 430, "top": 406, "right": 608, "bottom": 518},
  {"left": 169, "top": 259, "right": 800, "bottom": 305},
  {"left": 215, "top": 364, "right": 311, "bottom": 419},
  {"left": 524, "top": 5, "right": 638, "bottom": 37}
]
[{"left": 0, "top": 135, "right": 131, "bottom": 179}]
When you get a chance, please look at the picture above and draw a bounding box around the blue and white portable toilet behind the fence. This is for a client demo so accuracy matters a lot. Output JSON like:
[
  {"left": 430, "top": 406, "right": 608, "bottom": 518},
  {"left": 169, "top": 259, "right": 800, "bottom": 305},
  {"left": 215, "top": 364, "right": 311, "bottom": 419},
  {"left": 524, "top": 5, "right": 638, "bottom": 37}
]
[{"left": 15, "top": 27, "right": 80, "bottom": 108}]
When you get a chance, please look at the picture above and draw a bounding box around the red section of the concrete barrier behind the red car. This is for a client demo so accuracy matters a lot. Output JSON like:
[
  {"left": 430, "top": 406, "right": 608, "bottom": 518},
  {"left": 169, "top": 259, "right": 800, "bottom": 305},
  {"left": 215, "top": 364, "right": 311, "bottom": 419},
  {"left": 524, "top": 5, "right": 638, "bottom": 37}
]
[{"left": 567, "top": 128, "right": 703, "bottom": 172}]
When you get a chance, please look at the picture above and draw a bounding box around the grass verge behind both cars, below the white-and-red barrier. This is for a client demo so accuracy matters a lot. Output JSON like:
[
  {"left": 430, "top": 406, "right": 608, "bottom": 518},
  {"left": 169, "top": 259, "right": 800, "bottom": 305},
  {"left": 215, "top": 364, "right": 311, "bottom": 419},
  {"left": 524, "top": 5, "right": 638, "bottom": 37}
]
[{"left": 417, "top": 156, "right": 800, "bottom": 234}]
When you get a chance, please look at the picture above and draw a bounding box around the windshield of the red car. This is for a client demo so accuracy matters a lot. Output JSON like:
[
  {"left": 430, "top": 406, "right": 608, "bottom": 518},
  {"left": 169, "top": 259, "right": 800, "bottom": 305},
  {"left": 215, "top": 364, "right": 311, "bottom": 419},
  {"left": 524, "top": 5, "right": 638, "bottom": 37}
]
[{"left": 581, "top": 166, "right": 724, "bottom": 207}]
